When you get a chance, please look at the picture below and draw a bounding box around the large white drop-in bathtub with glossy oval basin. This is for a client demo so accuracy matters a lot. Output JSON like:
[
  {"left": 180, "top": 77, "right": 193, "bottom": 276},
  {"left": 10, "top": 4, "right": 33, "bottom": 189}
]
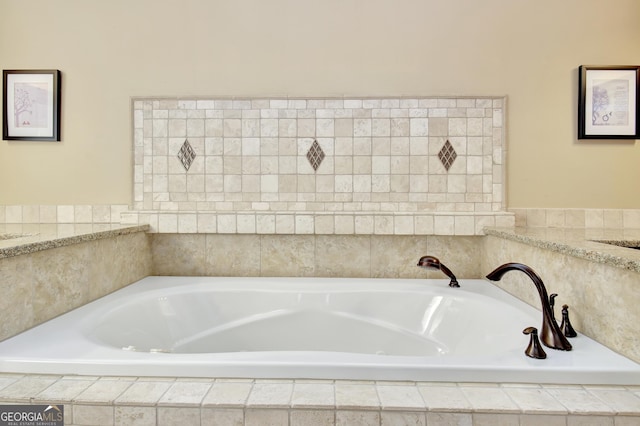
[{"left": 0, "top": 277, "right": 640, "bottom": 384}]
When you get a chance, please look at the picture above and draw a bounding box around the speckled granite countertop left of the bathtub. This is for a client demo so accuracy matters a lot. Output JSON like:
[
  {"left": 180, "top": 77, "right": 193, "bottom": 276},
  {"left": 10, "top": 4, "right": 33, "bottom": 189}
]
[{"left": 0, "top": 223, "right": 149, "bottom": 259}]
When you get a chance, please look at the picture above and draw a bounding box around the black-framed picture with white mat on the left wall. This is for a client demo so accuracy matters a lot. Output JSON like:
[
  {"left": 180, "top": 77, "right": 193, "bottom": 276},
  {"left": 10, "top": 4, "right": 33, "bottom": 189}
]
[{"left": 2, "top": 70, "right": 61, "bottom": 142}]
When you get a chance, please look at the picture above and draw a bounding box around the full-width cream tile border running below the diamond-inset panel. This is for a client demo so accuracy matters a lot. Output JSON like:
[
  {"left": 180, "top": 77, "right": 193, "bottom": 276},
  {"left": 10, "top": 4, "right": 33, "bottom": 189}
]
[{"left": 0, "top": 204, "right": 640, "bottom": 235}]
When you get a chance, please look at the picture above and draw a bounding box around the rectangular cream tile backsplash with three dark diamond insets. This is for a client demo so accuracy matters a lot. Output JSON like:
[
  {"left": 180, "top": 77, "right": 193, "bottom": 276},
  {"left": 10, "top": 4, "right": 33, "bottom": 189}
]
[{"left": 127, "top": 97, "right": 512, "bottom": 235}]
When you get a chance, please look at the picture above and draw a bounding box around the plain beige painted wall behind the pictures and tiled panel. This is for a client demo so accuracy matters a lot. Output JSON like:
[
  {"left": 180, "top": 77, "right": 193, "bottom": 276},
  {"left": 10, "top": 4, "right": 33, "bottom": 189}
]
[{"left": 0, "top": 0, "right": 640, "bottom": 208}]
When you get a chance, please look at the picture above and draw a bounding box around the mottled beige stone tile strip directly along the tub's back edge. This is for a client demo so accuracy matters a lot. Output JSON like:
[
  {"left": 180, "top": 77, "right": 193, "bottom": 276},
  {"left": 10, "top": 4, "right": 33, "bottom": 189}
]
[{"left": 150, "top": 233, "right": 480, "bottom": 279}]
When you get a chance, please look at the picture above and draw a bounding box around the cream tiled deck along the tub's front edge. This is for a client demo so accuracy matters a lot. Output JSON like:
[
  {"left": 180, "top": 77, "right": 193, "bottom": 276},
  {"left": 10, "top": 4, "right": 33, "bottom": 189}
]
[{"left": 0, "top": 374, "right": 640, "bottom": 426}]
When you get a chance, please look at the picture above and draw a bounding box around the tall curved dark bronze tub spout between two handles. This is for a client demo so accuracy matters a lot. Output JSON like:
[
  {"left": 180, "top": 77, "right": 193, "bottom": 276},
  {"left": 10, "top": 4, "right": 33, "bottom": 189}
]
[{"left": 487, "top": 263, "right": 571, "bottom": 351}]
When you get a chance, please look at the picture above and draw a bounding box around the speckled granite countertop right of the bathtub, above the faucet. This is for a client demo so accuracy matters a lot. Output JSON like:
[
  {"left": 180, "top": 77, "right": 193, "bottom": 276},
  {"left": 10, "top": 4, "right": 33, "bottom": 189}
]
[{"left": 485, "top": 227, "right": 640, "bottom": 272}]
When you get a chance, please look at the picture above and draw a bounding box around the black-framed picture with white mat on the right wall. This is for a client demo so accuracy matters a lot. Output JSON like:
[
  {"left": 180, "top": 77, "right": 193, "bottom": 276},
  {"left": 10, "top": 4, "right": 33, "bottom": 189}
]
[{"left": 578, "top": 65, "right": 640, "bottom": 139}]
